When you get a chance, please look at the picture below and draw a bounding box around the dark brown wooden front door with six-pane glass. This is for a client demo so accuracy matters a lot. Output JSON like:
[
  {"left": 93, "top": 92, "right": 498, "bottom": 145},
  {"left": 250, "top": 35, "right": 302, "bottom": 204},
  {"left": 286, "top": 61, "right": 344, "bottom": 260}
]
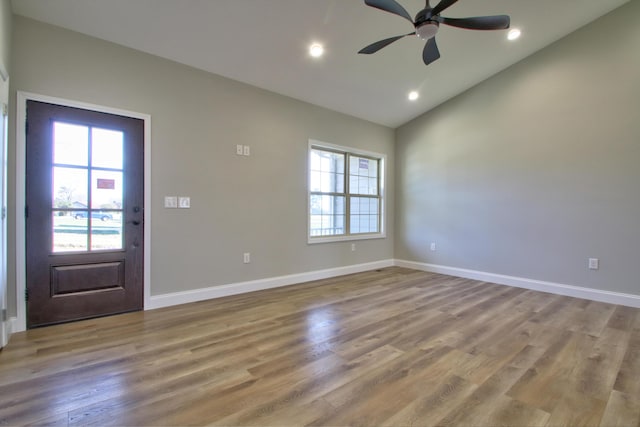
[{"left": 25, "top": 101, "right": 144, "bottom": 328}]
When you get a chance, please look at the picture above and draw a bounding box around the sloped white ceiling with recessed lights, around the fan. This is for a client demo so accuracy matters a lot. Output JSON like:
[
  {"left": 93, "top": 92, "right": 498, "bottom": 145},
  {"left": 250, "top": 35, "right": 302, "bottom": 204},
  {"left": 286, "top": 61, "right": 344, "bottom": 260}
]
[{"left": 12, "top": 0, "right": 628, "bottom": 128}]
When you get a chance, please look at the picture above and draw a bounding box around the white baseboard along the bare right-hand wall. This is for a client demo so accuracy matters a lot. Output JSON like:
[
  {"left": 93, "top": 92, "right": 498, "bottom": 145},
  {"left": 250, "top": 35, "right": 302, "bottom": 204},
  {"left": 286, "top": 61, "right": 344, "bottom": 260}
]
[{"left": 394, "top": 259, "right": 640, "bottom": 308}]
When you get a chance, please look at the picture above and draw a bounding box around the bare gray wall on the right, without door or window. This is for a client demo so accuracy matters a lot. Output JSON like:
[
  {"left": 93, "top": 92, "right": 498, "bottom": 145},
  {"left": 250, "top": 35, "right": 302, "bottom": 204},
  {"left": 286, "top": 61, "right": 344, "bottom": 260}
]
[{"left": 395, "top": 1, "right": 640, "bottom": 294}]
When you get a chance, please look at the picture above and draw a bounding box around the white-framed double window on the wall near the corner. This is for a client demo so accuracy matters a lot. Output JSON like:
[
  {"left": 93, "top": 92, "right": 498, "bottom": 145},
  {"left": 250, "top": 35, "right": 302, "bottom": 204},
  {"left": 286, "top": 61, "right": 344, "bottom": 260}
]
[{"left": 309, "top": 141, "right": 384, "bottom": 243}]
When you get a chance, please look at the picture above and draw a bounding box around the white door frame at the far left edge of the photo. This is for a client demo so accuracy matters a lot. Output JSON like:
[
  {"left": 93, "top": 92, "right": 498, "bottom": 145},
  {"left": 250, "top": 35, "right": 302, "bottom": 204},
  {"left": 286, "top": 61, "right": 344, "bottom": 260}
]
[{"left": 0, "top": 63, "right": 11, "bottom": 348}]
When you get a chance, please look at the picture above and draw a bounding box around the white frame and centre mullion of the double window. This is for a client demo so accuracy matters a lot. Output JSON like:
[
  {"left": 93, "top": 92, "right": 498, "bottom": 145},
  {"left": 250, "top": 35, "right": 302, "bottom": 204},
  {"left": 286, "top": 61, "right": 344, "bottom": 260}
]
[{"left": 305, "top": 139, "right": 387, "bottom": 244}]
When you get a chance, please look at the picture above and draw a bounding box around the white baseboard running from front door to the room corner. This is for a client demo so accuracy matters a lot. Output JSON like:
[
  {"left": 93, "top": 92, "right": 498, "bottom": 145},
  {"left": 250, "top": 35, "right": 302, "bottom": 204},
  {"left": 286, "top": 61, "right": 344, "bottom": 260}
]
[{"left": 146, "top": 260, "right": 393, "bottom": 309}]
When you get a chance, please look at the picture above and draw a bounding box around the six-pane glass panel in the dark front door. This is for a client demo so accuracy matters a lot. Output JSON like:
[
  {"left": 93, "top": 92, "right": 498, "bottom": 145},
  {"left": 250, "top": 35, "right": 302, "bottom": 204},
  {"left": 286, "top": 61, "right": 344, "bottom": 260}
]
[{"left": 51, "top": 122, "right": 124, "bottom": 253}]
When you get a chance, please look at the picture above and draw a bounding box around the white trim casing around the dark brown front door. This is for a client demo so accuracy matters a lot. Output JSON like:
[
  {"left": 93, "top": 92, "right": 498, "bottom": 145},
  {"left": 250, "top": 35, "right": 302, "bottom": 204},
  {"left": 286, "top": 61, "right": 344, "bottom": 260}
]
[{"left": 12, "top": 91, "right": 151, "bottom": 332}]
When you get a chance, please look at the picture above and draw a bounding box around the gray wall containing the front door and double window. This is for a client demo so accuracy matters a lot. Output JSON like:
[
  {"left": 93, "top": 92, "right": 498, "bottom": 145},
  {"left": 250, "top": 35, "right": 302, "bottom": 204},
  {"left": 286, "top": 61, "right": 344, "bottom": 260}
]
[{"left": 9, "top": 16, "right": 394, "bottom": 314}]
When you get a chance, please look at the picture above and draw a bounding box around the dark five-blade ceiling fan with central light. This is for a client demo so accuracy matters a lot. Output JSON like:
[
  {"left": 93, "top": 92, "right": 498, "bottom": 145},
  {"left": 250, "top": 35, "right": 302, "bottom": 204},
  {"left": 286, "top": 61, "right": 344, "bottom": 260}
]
[{"left": 358, "top": 0, "right": 510, "bottom": 65}]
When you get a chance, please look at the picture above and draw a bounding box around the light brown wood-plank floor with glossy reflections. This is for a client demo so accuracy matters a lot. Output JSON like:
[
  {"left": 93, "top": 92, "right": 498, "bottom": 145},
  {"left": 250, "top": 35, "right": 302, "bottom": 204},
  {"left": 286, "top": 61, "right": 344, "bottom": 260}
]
[{"left": 0, "top": 267, "right": 640, "bottom": 426}]
